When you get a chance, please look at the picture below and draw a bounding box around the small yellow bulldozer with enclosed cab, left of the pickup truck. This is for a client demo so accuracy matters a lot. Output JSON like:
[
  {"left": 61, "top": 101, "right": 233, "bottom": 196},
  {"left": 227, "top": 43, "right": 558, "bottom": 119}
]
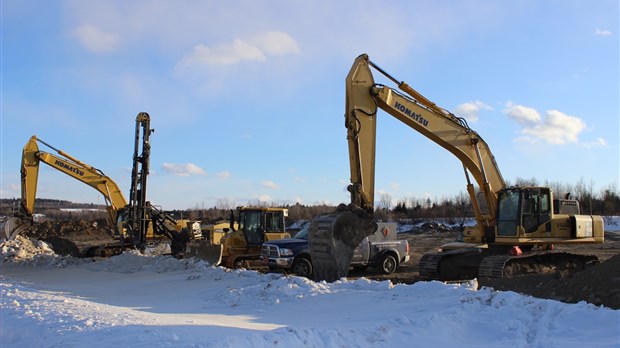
[{"left": 207, "top": 207, "right": 291, "bottom": 268}]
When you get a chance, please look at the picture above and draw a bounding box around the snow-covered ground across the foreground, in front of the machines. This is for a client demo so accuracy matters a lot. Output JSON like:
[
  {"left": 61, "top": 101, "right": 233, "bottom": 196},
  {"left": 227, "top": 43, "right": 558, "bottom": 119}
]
[{"left": 0, "top": 244, "right": 620, "bottom": 348}]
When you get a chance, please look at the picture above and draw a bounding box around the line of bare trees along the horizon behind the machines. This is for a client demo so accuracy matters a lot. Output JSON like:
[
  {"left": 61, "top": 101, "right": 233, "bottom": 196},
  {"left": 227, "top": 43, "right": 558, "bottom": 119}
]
[{"left": 0, "top": 178, "right": 620, "bottom": 223}]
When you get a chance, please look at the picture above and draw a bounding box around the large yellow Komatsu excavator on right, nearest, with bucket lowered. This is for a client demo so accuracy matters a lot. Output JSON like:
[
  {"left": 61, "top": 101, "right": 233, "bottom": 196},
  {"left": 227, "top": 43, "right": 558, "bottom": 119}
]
[{"left": 309, "top": 54, "right": 604, "bottom": 281}]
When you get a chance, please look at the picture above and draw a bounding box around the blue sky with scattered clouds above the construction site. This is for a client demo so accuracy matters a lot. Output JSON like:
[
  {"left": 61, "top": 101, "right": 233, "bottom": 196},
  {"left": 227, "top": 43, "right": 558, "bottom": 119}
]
[{"left": 0, "top": 0, "right": 620, "bottom": 209}]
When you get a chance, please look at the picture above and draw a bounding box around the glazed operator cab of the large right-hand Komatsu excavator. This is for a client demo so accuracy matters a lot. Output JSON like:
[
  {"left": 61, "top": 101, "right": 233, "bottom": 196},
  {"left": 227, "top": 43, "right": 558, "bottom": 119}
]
[{"left": 497, "top": 187, "right": 551, "bottom": 238}]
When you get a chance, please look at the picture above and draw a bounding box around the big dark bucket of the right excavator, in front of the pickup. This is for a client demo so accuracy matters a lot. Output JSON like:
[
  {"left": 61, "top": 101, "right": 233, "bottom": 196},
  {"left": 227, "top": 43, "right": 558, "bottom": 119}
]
[{"left": 308, "top": 205, "right": 377, "bottom": 282}]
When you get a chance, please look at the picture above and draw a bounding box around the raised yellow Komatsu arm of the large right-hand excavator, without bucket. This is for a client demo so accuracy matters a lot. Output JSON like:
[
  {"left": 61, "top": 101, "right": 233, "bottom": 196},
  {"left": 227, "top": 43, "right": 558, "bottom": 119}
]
[{"left": 345, "top": 54, "right": 505, "bottom": 232}]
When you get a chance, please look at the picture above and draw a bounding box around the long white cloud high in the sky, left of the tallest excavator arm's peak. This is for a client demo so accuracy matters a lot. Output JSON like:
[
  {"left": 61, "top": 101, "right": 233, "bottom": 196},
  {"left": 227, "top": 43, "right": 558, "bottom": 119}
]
[{"left": 176, "top": 31, "right": 299, "bottom": 69}]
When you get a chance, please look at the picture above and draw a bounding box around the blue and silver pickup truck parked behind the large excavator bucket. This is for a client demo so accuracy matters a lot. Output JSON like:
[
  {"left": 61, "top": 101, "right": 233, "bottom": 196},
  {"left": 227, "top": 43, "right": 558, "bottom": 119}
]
[{"left": 261, "top": 222, "right": 409, "bottom": 278}]
